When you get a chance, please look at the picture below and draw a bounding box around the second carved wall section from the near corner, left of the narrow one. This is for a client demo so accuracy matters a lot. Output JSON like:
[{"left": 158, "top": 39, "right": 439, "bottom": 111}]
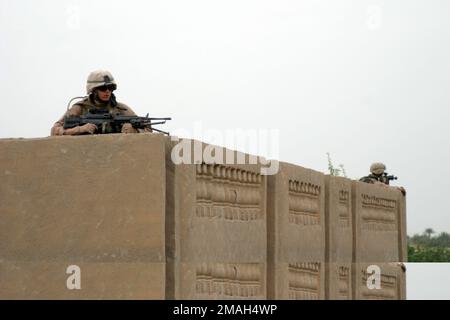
[{"left": 268, "top": 163, "right": 325, "bottom": 299}]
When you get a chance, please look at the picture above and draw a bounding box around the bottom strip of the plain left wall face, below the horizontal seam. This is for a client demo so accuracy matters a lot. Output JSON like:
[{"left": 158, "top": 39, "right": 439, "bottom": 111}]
[{"left": 0, "top": 258, "right": 165, "bottom": 300}]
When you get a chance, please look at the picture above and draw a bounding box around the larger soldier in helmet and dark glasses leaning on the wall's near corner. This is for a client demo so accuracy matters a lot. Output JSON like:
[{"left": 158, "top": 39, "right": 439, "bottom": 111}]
[{"left": 51, "top": 70, "right": 148, "bottom": 136}]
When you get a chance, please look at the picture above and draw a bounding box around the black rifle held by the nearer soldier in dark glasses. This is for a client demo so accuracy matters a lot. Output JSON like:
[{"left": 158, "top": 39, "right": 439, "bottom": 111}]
[{"left": 64, "top": 109, "right": 172, "bottom": 135}]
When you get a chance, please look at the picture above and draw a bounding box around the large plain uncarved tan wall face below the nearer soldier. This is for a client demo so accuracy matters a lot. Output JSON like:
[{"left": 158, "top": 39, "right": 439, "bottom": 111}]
[{"left": 0, "top": 135, "right": 165, "bottom": 299}]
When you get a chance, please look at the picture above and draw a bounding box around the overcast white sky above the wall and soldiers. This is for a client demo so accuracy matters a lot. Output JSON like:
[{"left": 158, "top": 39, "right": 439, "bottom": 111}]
[{"left": 0, "top": 0, "right": 450, "bottom": 298}]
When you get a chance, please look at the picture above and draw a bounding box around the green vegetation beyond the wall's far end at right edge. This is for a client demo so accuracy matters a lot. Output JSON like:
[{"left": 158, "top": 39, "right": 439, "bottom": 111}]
[{"left": 408, "top": 228, "right": 450, "bottom": 262}]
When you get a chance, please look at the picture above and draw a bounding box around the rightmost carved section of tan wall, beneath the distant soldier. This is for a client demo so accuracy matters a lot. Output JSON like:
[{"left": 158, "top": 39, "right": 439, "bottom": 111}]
[{"left": 352, "top": 181, "right": 407, "bottom": 300}]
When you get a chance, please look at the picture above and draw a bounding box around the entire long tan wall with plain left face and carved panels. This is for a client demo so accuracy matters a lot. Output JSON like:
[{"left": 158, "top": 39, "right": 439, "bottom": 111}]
[{"left": 0, "top": 134, "right": 407, "bottom": 299}]
